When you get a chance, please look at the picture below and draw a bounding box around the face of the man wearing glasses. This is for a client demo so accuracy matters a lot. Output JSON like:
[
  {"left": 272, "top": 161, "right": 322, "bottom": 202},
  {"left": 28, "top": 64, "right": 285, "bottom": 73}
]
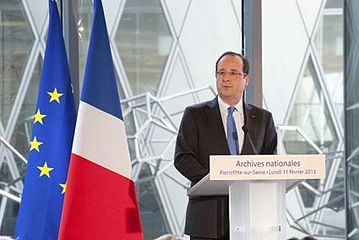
[{"left": 216, "top": 55, "right": 250, "bottom": 106}]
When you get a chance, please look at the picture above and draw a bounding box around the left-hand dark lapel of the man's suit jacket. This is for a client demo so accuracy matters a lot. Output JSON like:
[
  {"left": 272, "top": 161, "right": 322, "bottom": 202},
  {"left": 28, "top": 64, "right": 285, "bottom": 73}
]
[{"left": 207, "top": 97, "right": 229, "bottom": 154}]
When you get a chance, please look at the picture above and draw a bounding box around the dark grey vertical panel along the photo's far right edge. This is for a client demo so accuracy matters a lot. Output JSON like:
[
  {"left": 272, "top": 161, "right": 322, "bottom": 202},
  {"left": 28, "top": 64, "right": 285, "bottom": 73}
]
[{"left": 344, "top": 0, "right": 359, "bottom": 239}]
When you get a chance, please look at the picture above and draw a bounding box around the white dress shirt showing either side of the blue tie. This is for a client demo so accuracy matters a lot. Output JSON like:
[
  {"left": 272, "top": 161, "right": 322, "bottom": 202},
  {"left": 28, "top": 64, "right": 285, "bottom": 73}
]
[{"left": 218, "top": 96, "right": 244, "bottom": 152}]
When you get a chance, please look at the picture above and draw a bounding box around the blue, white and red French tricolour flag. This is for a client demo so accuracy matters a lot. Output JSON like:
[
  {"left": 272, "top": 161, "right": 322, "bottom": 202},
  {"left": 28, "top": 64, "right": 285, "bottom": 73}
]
[{"left": 59, "top": 0, "right": 143, "bottom": 240}]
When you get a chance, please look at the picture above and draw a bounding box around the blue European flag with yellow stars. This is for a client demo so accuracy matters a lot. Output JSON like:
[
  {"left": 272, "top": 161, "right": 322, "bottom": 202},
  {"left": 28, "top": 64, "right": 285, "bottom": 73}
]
[{"left": 15, "top": 0, "right": 76, "bottom": 240}]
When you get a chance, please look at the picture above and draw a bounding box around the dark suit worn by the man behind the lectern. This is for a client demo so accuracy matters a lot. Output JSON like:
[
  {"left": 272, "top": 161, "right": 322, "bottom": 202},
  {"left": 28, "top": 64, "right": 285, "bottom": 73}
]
[{"left": 174, "top": 97, "right": 277, "bottom": 238}]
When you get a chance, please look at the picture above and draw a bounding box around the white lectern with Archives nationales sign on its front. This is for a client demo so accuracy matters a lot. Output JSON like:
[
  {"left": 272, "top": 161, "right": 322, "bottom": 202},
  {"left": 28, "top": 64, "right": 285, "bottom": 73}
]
[{"left": 188, "top": 154, "right": 325, "bottom": 240}]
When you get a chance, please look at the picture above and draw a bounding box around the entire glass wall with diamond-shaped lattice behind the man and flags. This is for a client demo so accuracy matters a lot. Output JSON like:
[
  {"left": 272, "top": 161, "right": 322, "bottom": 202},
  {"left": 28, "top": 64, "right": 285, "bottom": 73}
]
[{"left": 0, "top": 0, "right": 352, "bottom": 239}]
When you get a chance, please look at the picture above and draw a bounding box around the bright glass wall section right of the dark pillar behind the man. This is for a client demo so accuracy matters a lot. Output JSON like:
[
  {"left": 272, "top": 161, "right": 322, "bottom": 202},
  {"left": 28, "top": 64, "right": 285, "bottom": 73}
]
[{"left": 262, "top": 0, "right": 346, "bottom": 239}]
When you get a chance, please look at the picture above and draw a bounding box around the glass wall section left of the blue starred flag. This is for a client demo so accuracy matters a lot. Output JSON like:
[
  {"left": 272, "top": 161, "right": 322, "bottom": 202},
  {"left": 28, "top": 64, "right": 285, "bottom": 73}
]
[{"left": 0, "top": 0, "right": 46, "bottom": 236}]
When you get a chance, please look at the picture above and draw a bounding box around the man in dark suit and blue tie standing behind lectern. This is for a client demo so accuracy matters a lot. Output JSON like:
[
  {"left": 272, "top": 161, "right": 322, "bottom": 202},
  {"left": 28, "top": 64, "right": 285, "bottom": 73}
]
[{"left": 175, "top": 52, "right": 277, "bottom": 239}]
